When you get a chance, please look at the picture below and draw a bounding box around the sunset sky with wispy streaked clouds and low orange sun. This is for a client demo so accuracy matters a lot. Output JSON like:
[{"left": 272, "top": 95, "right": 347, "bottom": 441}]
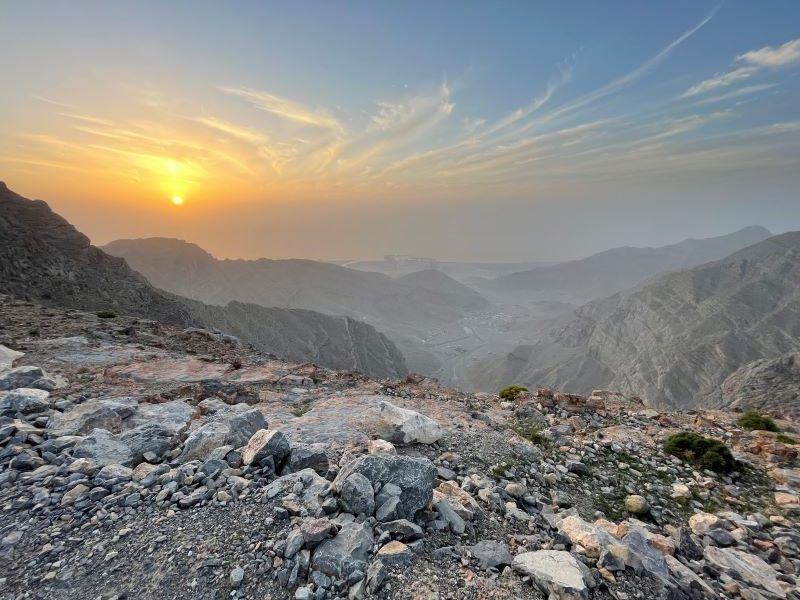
[{"left": 0, "top": 0, "right": 800, "bottom": 262}]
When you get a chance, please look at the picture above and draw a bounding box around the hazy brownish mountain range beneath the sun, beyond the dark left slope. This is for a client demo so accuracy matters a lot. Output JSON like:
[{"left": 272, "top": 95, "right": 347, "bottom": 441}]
[{"left": 104, "top": 238, "right": 486, "bottom": 329}]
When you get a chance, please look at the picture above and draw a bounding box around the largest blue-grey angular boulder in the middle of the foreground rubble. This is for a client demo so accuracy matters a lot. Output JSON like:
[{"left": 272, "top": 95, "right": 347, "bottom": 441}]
[{"left": 331, "top": 454, "right": 436, "bottom": 519}]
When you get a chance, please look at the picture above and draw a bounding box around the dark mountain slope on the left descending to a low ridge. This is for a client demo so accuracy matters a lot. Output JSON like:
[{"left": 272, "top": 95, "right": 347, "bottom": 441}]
[{"left": 0, "top": 184, "right": 406, "bottom": 377}]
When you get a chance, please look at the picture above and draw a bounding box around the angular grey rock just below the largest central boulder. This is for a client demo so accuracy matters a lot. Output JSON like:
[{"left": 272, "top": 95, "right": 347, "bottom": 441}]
[{"left": 311, "top": 523, "right": 374, "bottom": 579}]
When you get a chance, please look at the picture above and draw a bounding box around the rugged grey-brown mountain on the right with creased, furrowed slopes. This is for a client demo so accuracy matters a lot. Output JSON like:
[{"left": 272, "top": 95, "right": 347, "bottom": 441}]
[{"left": 468, "top": 232, "right": 800, "bottom": 414}]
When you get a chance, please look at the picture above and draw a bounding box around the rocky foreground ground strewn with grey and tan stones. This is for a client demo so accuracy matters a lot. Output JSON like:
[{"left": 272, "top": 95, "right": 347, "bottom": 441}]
[{"left": 0, "top": 297, "right": 800, "bottom": 599}]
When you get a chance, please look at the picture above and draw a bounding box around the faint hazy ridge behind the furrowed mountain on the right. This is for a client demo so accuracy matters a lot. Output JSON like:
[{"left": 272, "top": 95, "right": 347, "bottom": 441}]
[{"left": 483, "top": 226, "right": 771, "bottom": 301}]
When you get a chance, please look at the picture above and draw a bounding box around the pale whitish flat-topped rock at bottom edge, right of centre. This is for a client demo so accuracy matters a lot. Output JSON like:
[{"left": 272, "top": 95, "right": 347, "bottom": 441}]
[{"left": 511, "top": 550, "right": 589, "bottom": 600}]
